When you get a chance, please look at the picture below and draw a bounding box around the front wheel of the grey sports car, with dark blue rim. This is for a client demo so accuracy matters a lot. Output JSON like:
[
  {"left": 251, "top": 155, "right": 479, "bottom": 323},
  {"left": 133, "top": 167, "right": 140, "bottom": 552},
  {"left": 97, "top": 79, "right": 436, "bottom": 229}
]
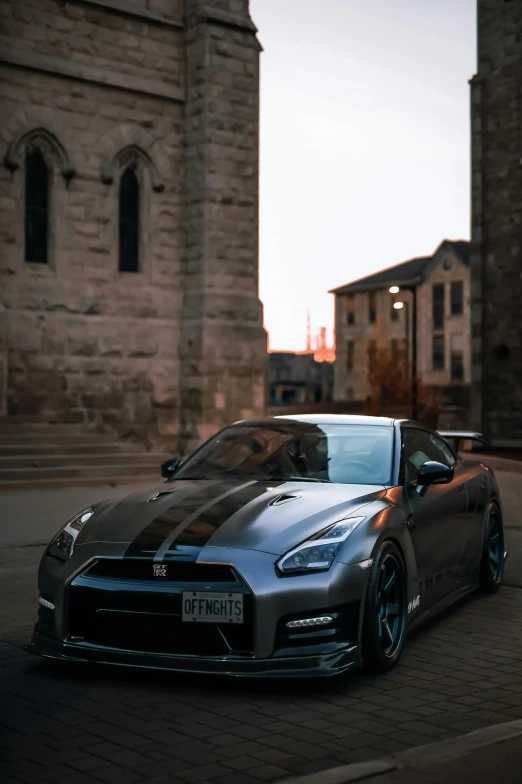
[{"left": 362, "top": 541, "right": 407, "bottom": 672}]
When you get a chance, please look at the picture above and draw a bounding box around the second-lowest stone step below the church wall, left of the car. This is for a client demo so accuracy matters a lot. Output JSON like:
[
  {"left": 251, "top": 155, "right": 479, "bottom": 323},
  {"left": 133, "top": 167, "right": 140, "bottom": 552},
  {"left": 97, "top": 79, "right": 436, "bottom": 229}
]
[{"left": 0, "top": 452, "right": 167, "bottom": 474}]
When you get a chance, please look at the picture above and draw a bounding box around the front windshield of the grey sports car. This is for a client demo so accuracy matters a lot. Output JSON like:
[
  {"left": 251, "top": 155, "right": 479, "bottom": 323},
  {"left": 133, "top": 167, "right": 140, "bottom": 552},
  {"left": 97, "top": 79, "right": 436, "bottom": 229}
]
[{"left": 173, "top": 419, "right": 393, "bottom": 485}]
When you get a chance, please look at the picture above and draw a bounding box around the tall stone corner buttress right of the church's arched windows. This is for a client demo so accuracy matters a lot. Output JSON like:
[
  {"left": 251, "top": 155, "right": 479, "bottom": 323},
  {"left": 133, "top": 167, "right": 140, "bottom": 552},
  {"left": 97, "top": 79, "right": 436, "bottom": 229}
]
[{"left": 180, "top": 0, "right": 267, "bottom": 454}]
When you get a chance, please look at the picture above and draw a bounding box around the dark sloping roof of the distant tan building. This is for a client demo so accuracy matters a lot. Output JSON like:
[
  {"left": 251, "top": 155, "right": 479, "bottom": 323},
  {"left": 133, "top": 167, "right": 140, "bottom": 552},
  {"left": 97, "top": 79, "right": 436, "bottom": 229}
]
[{"left": 329, "top": 240, "right": 469, "bottom": 294}]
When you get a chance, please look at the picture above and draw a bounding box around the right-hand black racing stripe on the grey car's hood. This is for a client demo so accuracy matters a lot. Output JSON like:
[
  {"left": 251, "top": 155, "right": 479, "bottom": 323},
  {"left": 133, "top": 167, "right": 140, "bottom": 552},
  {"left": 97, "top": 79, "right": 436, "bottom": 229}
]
[{"left": 169, "top": 482, "right": 274, "bottom": 551}]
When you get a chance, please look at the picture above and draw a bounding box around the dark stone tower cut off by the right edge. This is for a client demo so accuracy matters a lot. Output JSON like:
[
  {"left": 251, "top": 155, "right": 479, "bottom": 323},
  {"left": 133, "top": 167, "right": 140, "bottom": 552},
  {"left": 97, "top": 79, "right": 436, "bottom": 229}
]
[{"left": 470, "top": 0, "right": 522, "bottom": 446}]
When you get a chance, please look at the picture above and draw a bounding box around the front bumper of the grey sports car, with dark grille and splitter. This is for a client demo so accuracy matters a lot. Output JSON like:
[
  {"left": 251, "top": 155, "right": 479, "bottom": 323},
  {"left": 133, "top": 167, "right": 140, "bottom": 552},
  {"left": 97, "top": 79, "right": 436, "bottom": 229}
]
[{"left": 28, "top": 545, "right": 367, "bottom": 677}]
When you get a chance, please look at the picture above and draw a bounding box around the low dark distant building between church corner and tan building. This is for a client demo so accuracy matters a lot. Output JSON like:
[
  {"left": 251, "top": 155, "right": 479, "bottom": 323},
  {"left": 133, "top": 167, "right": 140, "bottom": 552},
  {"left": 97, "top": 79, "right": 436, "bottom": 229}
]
[{"left": 268, "top": 351, "right": 333, "bottom": 406}]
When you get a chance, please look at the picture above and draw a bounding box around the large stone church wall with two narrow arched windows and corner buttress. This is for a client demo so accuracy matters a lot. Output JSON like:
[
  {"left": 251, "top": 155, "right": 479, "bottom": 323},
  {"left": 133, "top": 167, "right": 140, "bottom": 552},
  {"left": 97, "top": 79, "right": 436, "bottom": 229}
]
[{"left": 0, "top": 0, "right": 267, "bottom": 453}]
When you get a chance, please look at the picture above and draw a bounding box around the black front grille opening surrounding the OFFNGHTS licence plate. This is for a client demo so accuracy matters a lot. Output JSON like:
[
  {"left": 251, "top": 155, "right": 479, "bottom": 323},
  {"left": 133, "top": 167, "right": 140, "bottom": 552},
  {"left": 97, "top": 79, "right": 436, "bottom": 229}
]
[{"left": 67, "top": 559, "right": 254, "bottom": 656}]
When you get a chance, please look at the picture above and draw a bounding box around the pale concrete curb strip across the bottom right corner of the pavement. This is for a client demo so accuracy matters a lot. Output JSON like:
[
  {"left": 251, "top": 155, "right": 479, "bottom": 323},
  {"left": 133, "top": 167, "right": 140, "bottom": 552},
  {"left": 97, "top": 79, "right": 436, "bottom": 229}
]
[{"left": 281, "top": 719, "right": 522, "bottom": 784}]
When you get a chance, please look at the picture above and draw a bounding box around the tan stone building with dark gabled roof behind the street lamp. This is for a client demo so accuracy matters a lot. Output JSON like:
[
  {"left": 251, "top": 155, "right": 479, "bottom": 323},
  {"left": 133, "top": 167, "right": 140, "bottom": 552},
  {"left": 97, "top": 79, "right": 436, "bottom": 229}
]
[{"left": 331, "top": 240, "right": 471, "bottom": 410}]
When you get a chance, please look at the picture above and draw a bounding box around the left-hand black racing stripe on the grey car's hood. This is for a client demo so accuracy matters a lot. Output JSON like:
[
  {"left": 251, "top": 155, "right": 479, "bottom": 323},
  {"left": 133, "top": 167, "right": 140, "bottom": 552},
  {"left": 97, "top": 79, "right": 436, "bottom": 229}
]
[{"left": 124, "top": 482, "right": 233, "bottom": 558}]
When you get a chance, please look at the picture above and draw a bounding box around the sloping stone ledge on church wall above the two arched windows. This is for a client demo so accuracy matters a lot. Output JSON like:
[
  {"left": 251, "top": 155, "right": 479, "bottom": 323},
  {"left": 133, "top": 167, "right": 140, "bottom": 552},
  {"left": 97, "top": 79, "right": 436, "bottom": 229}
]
[{"left": 0, "top": 46, "right": 185, "bottom": 103}]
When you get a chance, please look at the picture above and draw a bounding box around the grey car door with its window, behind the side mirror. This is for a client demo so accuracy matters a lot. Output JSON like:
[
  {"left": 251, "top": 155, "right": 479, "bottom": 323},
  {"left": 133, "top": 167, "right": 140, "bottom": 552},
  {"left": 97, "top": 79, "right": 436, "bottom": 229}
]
[{"left": 402, "top": 427, "right": 467, "bottom": 609}]
